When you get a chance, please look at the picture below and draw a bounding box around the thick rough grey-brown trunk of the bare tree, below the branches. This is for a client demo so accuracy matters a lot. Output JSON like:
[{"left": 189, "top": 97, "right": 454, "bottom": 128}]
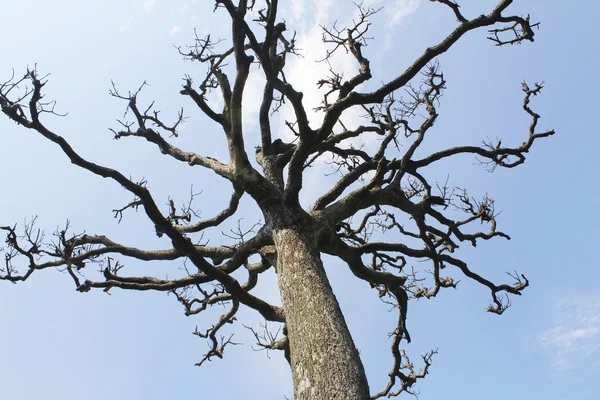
[{"left": 275, "top": 228, "right": 370, "bottom": 400}]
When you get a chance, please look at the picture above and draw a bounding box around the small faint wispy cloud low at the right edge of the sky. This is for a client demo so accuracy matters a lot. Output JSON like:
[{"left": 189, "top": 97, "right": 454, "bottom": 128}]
[{"left": 539, "top": 293, "right": 600, "bottom": 371}]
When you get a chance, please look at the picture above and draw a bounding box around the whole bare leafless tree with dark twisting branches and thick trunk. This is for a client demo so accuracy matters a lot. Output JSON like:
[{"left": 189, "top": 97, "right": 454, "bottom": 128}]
[{"left": 0, "top": 0, "right": 554, "bottom": 399}]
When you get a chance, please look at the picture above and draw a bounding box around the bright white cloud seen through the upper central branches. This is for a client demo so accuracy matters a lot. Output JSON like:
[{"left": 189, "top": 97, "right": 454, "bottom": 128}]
[{"left": 273, "top": 0, "right": 384, "bottom": 205}]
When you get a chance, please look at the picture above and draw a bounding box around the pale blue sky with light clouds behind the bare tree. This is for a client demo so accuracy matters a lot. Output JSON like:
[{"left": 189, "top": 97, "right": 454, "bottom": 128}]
[{"left": 0, "top": 0, "right": 600, "bottom": 400}]
